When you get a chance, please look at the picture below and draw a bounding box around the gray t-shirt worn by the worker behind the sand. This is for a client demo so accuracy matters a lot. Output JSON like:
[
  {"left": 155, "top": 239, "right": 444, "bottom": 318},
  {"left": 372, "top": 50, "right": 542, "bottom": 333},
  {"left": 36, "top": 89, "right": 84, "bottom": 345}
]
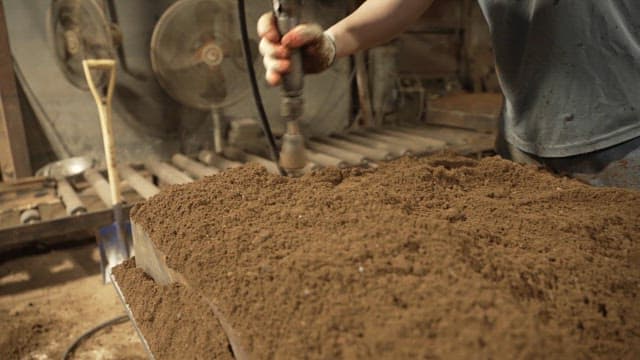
[{"left": 478, "top": 0, "right": 640, "bottom": 157}]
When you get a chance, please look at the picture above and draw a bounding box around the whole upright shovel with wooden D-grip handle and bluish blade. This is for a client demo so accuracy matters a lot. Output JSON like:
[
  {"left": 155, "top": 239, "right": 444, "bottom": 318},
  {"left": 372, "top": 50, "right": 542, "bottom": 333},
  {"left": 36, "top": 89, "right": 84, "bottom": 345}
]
[{"left": 82, "top": 59, "right": 130, "bottom": 283}]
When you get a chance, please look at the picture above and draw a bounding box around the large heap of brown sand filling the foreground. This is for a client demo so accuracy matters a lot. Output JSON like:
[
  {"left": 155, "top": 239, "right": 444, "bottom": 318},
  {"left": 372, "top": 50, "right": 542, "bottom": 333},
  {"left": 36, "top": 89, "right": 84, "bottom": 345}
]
[{"left": 115, "top": 155, "right": 640, "bottom": 359}]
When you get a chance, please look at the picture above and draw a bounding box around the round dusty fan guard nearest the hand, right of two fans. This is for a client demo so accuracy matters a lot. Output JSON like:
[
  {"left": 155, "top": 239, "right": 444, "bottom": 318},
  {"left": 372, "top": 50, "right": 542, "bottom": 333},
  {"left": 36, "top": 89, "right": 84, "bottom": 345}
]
[{"left": 151, "top": 0, "right": 257, "bottom": 110}]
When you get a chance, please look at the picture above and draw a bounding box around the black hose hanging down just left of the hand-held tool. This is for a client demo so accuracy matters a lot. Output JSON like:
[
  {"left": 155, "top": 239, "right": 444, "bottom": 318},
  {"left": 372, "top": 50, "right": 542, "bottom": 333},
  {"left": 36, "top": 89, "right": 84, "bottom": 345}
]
[{"left": 238, "top": 0, "right": 285, "bottom": 176}]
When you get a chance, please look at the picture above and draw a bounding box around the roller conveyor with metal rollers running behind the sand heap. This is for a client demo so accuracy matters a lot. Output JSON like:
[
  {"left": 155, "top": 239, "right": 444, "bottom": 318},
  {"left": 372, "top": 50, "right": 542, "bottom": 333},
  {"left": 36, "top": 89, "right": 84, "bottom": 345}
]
[{"left": 0, "top": 124, "right": 494, "bottom": 249}]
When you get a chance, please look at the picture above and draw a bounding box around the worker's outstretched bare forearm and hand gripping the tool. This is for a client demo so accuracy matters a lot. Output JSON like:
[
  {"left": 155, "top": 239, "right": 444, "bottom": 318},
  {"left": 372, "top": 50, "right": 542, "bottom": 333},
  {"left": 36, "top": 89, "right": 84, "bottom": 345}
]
[{"left": 258, "top": 0, "right": 433, "bottom": 85}]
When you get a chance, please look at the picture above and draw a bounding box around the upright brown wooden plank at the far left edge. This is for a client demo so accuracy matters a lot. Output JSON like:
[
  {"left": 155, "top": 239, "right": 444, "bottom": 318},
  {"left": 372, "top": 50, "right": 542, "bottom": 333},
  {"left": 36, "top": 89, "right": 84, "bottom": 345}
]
[{"left": 0, "top": 0, "right": 31, "bottom": 181}]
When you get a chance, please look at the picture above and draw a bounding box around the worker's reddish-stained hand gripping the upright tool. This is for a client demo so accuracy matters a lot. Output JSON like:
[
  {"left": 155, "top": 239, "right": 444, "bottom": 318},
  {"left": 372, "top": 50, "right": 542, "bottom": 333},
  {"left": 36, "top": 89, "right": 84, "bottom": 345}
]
[{"left": 258, "top": 12, "right": 336, "bottom": 86}]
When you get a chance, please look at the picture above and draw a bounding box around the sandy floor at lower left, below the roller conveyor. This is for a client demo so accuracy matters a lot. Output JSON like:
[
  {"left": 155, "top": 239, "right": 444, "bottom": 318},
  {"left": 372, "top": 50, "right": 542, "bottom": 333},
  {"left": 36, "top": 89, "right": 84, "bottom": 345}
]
[{"left": 0, "top": 243, "right": 147, "bottom": 360}]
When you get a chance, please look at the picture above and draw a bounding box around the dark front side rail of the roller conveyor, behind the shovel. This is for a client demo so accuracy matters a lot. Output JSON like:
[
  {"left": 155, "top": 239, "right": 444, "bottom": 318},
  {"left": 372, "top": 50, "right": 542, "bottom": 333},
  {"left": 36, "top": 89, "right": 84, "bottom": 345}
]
[{"left": 0, "top": 205, "right": 131, "bottom": 252}]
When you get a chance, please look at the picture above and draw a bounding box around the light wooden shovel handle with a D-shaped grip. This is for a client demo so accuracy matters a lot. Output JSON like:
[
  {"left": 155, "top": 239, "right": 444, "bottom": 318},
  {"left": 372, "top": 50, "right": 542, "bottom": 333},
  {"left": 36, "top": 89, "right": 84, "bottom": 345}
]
[{"left": 82, "top": 59, "right": 122, "bottom": 206}]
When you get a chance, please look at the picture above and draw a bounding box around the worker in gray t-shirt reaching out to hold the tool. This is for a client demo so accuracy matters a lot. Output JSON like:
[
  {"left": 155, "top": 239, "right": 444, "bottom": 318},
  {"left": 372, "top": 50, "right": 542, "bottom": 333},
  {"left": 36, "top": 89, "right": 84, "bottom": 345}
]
[{"left": 258, "top": 0, "right": 640, "bottom": 189}]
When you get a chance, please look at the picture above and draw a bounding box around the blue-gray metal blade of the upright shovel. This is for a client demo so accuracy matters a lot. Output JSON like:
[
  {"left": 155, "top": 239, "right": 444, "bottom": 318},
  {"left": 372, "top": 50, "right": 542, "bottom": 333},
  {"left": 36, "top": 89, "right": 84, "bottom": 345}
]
[{"left": 96, "top": 222, "right": 131, "bottom": 284}]
